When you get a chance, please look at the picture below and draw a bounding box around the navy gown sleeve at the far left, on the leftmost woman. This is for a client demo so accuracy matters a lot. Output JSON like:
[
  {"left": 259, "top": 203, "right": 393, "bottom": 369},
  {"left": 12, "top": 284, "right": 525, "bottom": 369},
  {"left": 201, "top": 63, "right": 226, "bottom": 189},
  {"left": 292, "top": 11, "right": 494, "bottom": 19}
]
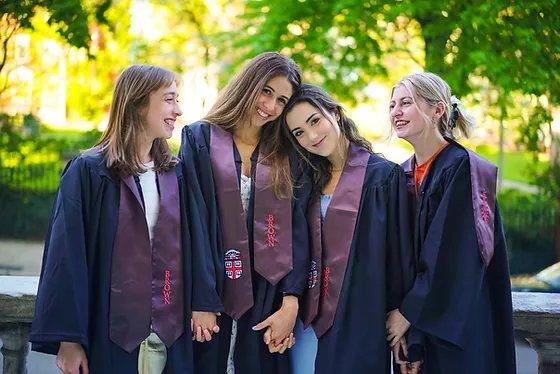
[{"left": 30, "top": 157, "right": 92, "bottom": 354}]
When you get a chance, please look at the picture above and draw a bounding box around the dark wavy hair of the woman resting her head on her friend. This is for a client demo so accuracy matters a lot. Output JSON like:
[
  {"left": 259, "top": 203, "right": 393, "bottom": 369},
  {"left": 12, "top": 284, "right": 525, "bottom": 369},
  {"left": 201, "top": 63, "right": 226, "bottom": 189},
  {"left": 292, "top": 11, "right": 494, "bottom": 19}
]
[{"left": 273, "top": 84, "right": 373, "bottom": 196}]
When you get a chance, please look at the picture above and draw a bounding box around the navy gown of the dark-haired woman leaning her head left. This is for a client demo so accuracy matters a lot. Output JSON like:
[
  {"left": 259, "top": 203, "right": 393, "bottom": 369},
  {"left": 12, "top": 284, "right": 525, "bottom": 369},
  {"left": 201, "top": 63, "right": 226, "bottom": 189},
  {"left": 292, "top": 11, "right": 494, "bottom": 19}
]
[{"left": 316, "top": 154, "right": 414, "bottom": 374}]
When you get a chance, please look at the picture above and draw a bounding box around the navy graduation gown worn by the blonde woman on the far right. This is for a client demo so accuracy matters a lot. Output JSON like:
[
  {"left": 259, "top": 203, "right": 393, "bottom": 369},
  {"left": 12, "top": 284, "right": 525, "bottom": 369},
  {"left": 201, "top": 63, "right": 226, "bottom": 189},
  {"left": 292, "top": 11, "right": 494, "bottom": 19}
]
[{"left": 400, "top": 142, "right": 516, "bottom": 374}]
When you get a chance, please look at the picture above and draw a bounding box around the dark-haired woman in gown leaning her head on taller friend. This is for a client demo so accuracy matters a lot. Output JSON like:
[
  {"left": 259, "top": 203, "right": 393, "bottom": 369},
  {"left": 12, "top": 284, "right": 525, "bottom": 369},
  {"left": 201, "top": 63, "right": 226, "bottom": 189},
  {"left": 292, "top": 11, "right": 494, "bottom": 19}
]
[{"left": 279, "top": 84, "right": 414, "bottom": 374}]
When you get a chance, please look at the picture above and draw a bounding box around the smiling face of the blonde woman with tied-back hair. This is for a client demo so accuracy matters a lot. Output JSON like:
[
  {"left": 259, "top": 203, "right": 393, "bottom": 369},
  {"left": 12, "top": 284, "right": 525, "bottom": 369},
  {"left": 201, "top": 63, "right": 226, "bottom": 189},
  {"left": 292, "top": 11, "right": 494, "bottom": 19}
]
[{"left": 389, "top": 84, "right": 441, "bottom": 143}]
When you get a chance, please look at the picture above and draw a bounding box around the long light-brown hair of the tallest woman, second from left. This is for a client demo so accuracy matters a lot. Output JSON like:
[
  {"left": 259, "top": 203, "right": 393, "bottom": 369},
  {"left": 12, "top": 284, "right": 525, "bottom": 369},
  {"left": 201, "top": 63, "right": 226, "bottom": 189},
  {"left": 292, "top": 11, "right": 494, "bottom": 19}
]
[{"left": 204, "top": 52, "right": 301, "bottom": 197}]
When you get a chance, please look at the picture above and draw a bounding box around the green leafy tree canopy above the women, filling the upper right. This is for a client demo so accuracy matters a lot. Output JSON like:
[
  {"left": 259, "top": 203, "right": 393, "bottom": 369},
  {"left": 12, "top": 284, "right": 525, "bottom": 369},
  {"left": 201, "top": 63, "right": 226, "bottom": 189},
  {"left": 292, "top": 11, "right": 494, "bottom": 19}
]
[{"left": 232, "top": 0, "right": 560, "bottom": 259}]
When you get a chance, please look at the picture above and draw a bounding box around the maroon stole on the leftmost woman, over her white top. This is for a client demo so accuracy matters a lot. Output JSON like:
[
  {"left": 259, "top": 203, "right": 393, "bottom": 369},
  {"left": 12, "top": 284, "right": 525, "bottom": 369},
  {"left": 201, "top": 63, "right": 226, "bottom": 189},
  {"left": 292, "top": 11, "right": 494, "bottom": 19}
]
[{"left": 109, "top": 168, "right": 185, "bottom": 353}]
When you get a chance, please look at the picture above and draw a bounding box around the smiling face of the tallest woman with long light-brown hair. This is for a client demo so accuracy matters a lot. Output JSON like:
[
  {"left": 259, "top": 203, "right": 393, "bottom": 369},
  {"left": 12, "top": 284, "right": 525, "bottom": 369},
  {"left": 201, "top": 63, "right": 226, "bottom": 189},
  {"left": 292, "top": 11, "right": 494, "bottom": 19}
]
[{"left": 252, "top": 76, "right": 294, "bottom": 127}]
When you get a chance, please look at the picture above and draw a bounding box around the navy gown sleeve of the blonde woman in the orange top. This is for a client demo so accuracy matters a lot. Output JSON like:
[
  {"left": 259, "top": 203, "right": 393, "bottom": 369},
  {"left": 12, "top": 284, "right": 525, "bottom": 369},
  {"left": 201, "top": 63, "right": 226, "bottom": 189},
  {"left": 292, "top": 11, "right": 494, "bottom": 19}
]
[{"left": 400, "top": 158, "right": 485, "bottom": 347}]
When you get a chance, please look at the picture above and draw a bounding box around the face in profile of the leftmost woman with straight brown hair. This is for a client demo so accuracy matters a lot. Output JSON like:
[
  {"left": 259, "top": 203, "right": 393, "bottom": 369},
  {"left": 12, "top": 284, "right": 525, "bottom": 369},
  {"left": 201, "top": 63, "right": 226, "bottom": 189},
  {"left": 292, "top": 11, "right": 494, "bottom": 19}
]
[{"left": 142, "top": 82, "right": 183, "bottom": 139}]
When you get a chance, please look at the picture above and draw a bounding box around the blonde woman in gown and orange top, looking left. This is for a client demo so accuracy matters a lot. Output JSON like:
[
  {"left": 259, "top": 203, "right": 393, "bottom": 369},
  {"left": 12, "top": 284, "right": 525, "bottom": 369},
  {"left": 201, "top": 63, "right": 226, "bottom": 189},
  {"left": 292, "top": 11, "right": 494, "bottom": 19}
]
[{"left": 388, "top": 73, "right": 515, "bottom": 374}]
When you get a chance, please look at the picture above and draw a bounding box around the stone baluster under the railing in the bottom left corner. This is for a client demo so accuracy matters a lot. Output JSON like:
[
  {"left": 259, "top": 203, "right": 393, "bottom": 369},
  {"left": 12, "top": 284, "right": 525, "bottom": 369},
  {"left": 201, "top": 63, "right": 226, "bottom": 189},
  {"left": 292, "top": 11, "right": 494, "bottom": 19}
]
[{"left": 0, "top": 323, "right": 29, "bottom": 374}]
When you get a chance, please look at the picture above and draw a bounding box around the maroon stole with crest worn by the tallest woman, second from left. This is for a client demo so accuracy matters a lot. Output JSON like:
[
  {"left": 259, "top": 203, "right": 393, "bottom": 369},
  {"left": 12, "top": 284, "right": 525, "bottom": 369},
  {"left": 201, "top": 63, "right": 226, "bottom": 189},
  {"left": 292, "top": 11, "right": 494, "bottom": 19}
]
[{"left": 210, "top": 125, "right": 293, "bottom": 320}]
